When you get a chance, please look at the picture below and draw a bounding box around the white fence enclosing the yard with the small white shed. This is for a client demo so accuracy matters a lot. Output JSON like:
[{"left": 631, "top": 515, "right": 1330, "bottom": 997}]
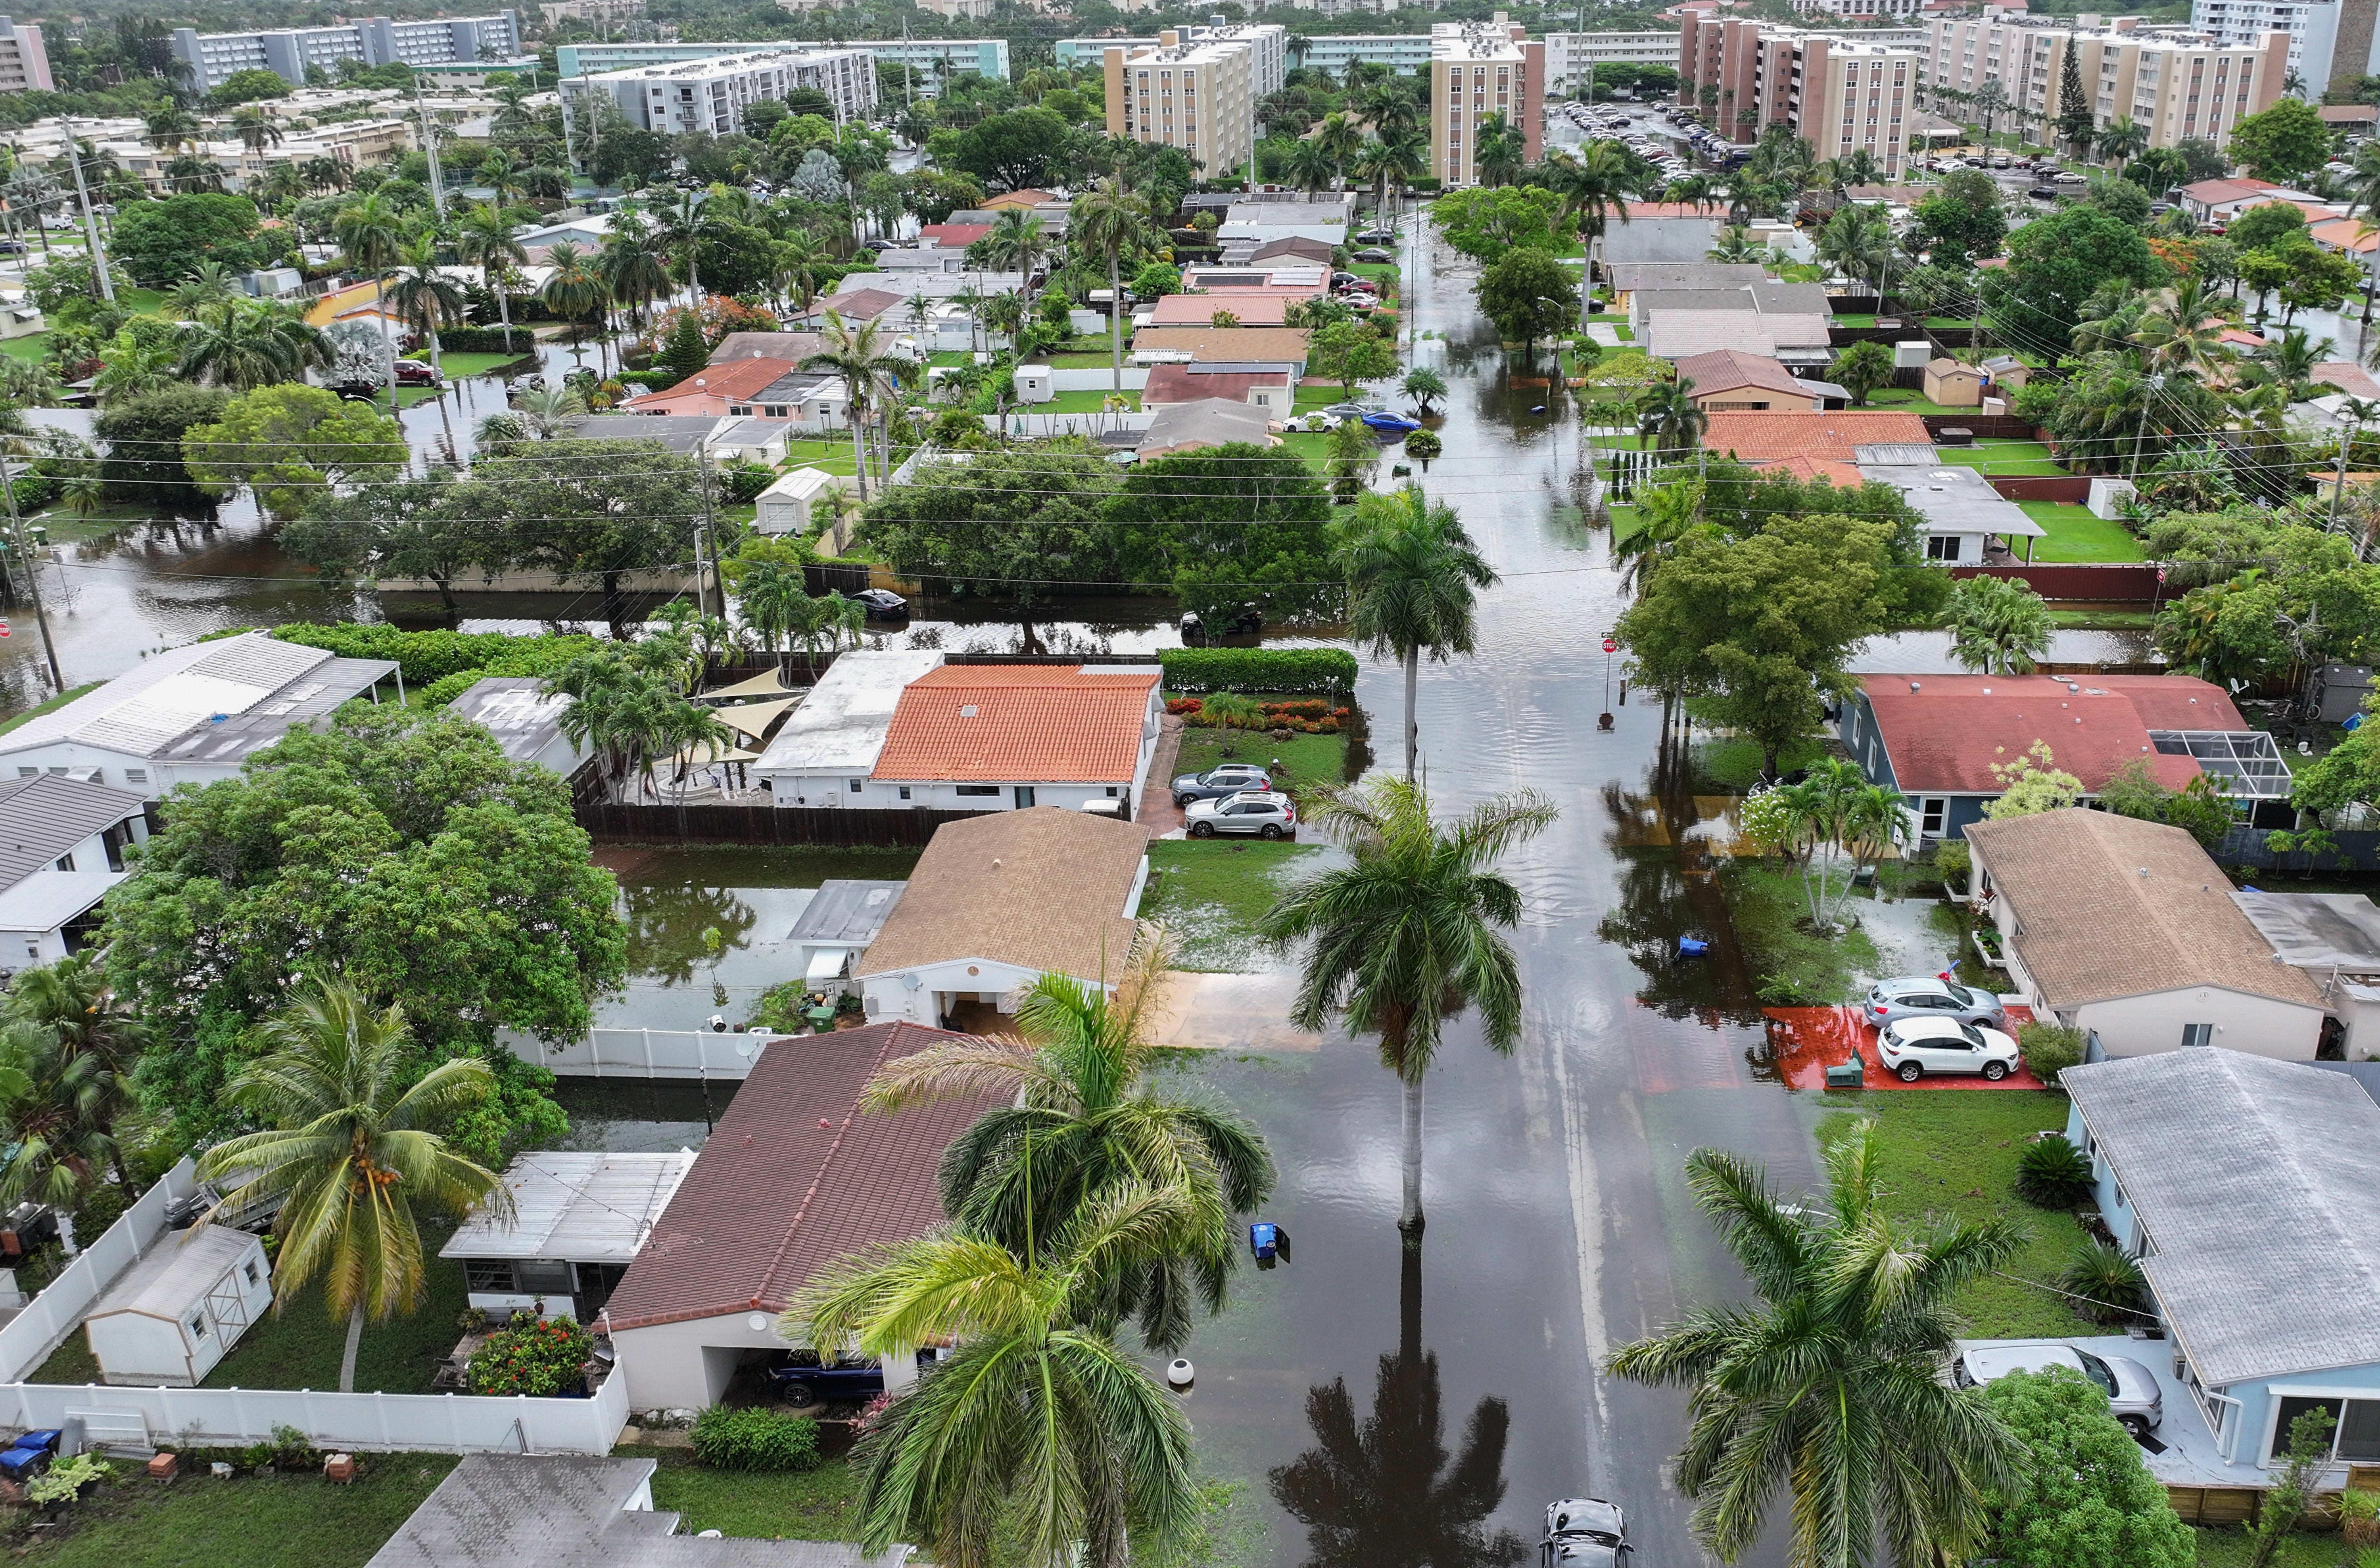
[{"left": 0, "top": 1152, "right": 628, "bottom": 1454}]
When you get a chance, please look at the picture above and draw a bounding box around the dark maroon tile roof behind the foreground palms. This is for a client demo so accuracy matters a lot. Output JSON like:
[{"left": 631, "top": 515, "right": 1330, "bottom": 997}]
[{"left": 605, "top": 1023, "right": 997, "bottom": 1330}]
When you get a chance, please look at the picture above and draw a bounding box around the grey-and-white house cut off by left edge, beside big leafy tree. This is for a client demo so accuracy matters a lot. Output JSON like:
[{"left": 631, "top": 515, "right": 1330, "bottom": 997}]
[{"left": 0, "top": 773, "right": 148, "bottom": 973}]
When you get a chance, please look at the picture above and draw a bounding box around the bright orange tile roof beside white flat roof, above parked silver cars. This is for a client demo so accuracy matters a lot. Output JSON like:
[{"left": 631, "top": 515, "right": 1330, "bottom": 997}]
[{"left": 873, "top": 664, "right": 1159, "bottom": 783}]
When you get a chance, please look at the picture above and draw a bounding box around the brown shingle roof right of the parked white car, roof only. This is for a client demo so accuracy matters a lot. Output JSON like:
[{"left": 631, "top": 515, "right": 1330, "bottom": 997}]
[{"left": 1966, "top": 807, "right": 2323, "bottom": 1006}]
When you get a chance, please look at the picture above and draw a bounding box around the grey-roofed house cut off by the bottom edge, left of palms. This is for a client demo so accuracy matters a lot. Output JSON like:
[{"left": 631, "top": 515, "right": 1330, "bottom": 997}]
[{"left": 367, "top": 1454, "right": 912, "bottom": 1568}]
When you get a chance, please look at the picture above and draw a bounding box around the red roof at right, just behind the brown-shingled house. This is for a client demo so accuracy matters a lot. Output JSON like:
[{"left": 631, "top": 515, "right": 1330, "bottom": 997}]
[{"left": 1861, "top": 676, "right": 2247, "bottom": 795}]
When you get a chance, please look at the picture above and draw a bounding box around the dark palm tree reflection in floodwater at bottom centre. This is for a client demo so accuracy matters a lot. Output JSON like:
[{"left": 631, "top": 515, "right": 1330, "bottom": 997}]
[{"left": 1269, "top": 1247, "right": 1528, "bottom": 1568}]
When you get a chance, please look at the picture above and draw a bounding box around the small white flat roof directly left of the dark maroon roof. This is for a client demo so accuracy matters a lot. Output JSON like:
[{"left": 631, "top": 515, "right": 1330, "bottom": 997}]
[{"left": 438, "top": 1149, "right": 695, "bottom": 1263}]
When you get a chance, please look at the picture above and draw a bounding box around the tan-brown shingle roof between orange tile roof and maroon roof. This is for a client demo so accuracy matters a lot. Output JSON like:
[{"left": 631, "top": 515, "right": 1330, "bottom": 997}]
[{"left": 852, "top": 807, "right": 1150, "bottom": 980}]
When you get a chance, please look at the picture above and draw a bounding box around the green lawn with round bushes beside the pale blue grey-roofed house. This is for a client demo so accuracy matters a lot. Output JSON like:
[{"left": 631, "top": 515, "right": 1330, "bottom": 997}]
[{"left": 1818, "top": 1090, "right": 2106, "bottom": 1340}]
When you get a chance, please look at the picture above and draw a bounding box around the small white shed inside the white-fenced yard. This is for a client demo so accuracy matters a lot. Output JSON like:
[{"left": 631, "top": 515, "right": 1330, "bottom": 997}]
[{"left": 83, "top": 1225, "right": 274, "bottom": 1387}]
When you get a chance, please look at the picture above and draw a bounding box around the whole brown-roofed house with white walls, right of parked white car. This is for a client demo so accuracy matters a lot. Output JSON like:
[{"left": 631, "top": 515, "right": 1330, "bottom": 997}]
[{"left": 1966, "top": 807, "right": 2323, "bottom": 1061}]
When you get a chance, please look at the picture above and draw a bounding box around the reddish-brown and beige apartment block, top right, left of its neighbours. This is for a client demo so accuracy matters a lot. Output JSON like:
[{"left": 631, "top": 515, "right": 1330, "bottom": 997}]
[{"left": 1678, "top": 17, "right": 1925, "bottom": 183}]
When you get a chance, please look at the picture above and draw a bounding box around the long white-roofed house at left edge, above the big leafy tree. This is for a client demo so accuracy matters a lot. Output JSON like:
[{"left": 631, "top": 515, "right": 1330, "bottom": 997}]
[{"left": 0, "top": 631, "right": 402, "bottom": 799}]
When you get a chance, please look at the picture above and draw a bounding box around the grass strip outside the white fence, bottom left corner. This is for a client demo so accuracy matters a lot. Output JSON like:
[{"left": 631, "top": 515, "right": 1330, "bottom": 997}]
[{"left": 0, "top": 1454, "right": 455, "bottom": 1568}]
